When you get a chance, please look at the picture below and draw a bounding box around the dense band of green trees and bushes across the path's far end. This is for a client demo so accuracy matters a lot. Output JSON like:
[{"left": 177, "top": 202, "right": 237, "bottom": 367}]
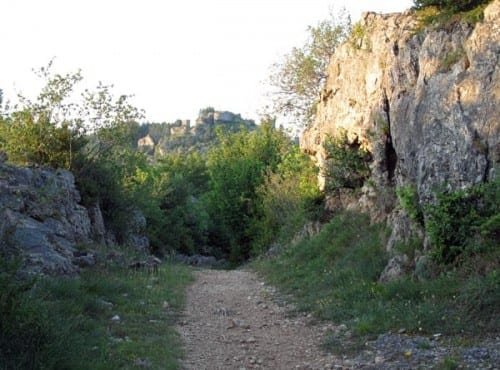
[{"left": 0, "top": 68, "right": 320, "bottom": 262}]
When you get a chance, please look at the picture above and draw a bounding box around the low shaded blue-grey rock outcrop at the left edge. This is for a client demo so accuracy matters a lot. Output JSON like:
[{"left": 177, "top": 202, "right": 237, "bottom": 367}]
[{"left": 0, "top": 163, "right": 92, "bottom": 274}]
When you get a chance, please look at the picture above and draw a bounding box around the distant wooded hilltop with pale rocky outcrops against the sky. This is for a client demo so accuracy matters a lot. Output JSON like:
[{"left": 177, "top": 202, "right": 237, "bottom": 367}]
[{"left": 137, "top": 107, "right": 257, "bottom": 156}]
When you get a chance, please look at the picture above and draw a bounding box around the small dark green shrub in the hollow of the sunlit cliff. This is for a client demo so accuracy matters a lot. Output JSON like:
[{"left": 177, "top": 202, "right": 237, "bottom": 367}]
[{"left": 323, "top": 131, "right": 370, "bottom": 191}]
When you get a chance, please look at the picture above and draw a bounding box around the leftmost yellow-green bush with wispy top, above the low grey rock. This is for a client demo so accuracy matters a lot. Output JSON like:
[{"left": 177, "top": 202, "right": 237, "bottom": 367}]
[{"left": 0, "top": 63, "right": 85, "bottom": 169}]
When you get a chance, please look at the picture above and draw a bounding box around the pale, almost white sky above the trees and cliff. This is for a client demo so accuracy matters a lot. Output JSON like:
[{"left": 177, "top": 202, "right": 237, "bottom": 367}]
[{"left": 0, "top": 0, "right": 413, "bottom": 122}]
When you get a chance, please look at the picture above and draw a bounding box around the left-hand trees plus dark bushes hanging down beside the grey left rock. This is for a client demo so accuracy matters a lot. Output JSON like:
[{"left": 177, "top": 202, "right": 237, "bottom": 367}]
[{"left": 0, "top": 62, "right": 145, "bottom": 243}]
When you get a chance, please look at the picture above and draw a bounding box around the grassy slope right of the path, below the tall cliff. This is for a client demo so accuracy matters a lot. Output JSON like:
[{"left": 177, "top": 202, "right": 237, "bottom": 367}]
[{"left": 254, "top": 213, "right": 500, "bottom": 352}]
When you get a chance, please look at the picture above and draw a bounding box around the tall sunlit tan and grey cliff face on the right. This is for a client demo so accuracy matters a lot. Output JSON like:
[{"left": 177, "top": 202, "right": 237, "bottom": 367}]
[{"left": 301, "top": 0, "right": 500, "bottom": 278}]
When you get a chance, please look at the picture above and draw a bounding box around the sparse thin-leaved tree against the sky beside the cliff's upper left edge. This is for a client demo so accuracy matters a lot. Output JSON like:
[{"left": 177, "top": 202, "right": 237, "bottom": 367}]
[{"left": 269, "top": 10, "right": 351, "bottom": 127}]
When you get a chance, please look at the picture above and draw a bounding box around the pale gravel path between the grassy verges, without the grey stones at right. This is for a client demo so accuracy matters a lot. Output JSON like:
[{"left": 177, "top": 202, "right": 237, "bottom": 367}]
[{"left": 178, "top": 270, "right": 336, "bottom": 370}]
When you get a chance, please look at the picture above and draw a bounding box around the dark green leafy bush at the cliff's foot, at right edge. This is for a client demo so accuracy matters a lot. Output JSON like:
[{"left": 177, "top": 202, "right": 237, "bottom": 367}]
[{"left": 424, "top": 176, "right": 500, "bottom": 264}]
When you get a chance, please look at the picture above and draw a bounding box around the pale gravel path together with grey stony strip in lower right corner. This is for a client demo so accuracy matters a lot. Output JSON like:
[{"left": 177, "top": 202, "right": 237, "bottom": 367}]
[{"left": 177, "top": 270, "right": 500, "bottom": 370}]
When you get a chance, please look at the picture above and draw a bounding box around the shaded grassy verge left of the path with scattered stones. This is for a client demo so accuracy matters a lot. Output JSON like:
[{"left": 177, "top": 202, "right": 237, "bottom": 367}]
[{"left": 0, "top": 253, "right": 191, "bottom": 369}]
